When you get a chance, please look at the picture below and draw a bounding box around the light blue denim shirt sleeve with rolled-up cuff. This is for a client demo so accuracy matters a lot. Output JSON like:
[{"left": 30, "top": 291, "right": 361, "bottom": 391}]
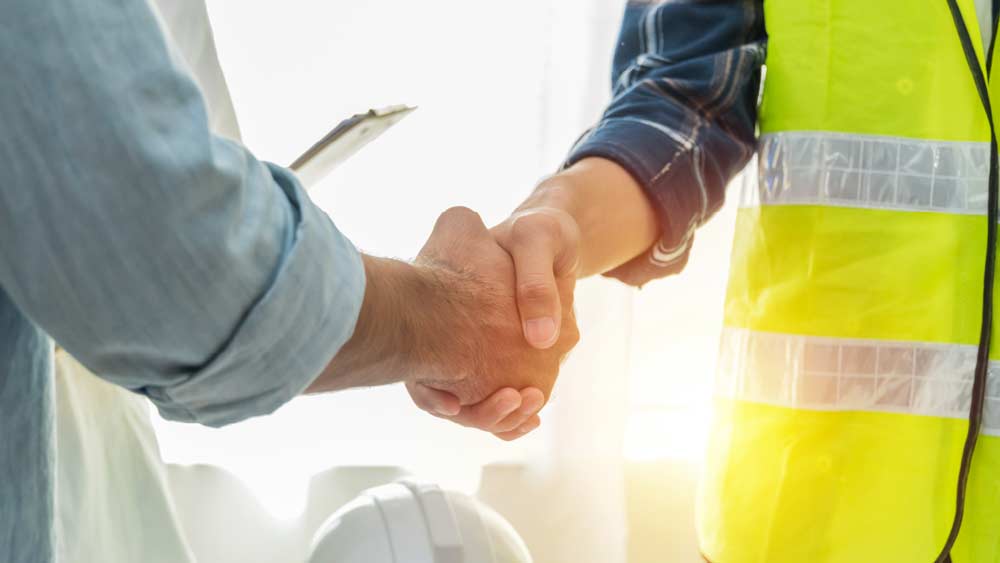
[{"left": 0, "top": 0, "right": 365, "bottom": 425}]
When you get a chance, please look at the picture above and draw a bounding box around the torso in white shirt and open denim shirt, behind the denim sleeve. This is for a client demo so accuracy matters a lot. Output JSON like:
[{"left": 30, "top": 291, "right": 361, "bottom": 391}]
[{"left": 0, "top": 0, "right": 239, "bottom": 563}]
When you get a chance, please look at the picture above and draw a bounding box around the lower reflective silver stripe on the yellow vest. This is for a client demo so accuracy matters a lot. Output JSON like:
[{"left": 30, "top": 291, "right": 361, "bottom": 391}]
[{"left": 716, "top": 328, "right": 1000, "bottom": 435}]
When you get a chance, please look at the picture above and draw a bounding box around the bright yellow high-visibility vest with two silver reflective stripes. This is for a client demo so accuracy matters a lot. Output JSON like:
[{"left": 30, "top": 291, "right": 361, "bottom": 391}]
[{"left": 697, "top": 0, "right": 1000, "bottom": 563}]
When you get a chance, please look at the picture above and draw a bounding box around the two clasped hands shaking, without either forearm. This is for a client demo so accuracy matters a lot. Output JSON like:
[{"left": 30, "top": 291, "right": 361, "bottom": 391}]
[{"left": 405, "top": 207, "right": 579, "bottom": 440}]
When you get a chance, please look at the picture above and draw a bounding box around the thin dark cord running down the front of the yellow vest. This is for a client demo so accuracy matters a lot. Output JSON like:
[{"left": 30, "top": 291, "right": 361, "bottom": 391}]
[{"left": 934, "top": 0, "right": 1000, "bottom": 563}]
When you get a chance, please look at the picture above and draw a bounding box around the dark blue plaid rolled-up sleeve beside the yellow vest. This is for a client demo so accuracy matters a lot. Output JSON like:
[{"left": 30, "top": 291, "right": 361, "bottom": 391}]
[{"left": 567, "top": 0, "right": 766, "bottom": 285}]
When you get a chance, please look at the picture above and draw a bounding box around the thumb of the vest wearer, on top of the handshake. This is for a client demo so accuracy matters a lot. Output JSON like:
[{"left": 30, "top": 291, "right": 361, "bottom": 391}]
[{"left": 507, "top": 213, "right": 562, "bottom": 349}]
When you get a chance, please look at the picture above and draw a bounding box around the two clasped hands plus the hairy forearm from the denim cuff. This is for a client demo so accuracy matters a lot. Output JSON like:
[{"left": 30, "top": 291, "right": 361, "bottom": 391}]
[{"left": 310, "top": 203, "right": 580, "bottom": 440}]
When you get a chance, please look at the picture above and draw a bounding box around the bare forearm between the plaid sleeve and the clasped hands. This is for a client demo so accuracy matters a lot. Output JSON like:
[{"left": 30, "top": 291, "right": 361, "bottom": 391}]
[{"left": 518, "top": 158, "right": 659, "bottom": 278}]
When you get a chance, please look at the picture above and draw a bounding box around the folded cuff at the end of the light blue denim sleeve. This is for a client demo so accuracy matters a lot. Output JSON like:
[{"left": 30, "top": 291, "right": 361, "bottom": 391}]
[{"left": 145, "top": 165, "right": 365, "bottom": 427}]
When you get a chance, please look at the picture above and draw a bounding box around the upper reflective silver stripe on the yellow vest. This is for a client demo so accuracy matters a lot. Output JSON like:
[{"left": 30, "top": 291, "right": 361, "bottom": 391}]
[{"left": 740, "top": 131, "right": 990, "bottom": 215}]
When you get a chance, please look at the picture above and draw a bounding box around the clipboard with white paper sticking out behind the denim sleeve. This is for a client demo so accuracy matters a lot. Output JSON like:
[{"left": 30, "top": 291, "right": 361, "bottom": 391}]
[{"left": 289, "top": 106, "right": 416, "bottom": 189}]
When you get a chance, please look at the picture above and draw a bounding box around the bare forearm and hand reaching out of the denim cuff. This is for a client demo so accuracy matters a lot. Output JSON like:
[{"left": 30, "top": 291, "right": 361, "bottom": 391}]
[{"left": 310, "top": 208, "right": 579, "bottom": 439}]
